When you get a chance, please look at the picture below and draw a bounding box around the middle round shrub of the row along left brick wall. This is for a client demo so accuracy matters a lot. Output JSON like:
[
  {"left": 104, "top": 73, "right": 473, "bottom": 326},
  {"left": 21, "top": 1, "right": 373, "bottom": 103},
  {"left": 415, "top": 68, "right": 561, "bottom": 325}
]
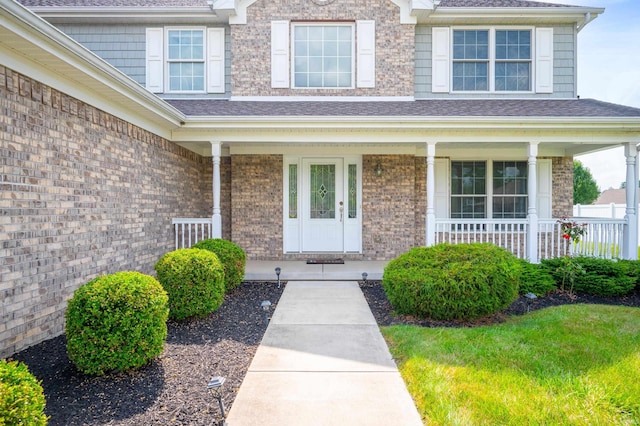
[{"left": 155, "top": 248, "right": 224, "bottom": 320}]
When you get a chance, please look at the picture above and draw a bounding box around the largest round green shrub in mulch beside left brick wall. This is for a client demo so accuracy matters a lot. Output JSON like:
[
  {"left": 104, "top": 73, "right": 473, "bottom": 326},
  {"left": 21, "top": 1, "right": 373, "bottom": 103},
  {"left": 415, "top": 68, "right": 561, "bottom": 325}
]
[{"left": 66, "top": 272, "right": 168, "bottom": 375}]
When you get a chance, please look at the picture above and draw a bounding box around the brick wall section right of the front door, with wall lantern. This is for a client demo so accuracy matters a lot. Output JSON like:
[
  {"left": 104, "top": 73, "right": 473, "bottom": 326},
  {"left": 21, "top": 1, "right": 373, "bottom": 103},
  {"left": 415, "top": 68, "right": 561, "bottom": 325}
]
[{"left": 362, "top": 155, "right": 416, "bottom": 260}]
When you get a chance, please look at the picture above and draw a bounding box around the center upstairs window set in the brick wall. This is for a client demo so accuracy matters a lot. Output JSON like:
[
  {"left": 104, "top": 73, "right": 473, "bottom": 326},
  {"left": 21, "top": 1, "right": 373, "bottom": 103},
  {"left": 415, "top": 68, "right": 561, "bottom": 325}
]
[{"left": 293, "top": 25, "right": 354, "bottom": 88}]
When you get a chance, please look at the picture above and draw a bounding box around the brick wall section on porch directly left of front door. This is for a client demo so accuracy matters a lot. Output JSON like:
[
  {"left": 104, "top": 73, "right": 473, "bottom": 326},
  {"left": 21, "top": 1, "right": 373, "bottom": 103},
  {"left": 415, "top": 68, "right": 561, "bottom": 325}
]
[{"left": 231, "top": 155, "right": 283, "bottom": 260}]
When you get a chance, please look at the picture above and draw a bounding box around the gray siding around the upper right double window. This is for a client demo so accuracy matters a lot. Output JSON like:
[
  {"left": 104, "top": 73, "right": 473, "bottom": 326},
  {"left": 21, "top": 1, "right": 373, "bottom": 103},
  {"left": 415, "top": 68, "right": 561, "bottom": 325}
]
[{"left": 415, "top": 25, "right": 577, "bottom": 99}]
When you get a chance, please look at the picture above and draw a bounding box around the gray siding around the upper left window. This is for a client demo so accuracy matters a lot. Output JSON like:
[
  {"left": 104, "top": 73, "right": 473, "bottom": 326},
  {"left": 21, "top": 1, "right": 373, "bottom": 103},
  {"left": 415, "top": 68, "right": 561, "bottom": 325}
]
[{"left": 56, "top": 24, "right": 231, "bottom": 98}]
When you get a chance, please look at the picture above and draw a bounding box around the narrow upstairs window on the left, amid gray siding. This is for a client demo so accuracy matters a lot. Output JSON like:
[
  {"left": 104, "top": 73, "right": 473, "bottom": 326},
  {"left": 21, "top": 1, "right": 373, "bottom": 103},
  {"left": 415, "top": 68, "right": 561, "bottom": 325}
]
[{"left": 167, "top": 30, "right": 204, "bottom": 92}]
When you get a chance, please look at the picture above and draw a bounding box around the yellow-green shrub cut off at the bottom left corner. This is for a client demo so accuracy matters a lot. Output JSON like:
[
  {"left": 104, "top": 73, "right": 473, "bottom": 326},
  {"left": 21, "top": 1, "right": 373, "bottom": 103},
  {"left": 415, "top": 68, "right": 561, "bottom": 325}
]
[{"left": 0, "top": 360, "right": 47, "bottom": 426}]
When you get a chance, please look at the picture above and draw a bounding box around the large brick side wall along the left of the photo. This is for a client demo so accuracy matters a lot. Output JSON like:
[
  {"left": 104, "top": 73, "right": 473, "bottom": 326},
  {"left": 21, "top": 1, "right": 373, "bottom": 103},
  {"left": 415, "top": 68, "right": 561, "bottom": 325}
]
[{"left": 0, "top": 67, "right": 211, "bottom": 357}]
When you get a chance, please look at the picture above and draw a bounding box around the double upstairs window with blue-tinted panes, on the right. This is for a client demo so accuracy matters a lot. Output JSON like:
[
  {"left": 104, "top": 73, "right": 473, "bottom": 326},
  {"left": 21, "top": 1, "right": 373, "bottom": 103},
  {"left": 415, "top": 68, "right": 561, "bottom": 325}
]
[{"left": 452, "top": 29, "right": 532, "bottom": 92}]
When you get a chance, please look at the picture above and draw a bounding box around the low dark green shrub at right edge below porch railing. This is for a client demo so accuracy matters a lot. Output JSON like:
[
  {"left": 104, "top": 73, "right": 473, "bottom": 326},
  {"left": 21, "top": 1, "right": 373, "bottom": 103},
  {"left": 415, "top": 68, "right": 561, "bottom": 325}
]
[{"left": 541, "top": 256, "right": 637, "bottom": 296}]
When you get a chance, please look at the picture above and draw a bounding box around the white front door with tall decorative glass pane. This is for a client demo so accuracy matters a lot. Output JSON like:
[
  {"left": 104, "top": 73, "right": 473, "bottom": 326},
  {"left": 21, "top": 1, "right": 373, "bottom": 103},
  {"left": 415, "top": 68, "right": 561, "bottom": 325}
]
[{"left": 301, "top": 158, "right": 345, "bottom": 252}]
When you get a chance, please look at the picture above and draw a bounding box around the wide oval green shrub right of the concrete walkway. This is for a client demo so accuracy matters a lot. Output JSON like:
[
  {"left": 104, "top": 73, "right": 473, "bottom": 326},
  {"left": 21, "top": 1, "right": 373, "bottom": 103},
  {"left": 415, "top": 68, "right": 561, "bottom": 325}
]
[{"left": 382, "top": 243, "right": 521, "bottom": 320}]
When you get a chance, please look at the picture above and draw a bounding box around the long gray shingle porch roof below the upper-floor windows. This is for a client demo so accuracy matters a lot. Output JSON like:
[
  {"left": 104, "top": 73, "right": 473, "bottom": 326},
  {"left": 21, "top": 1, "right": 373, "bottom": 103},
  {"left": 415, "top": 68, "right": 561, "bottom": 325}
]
[{"left": 167, "top": 99, "right": 640, "bottom": 120}]
